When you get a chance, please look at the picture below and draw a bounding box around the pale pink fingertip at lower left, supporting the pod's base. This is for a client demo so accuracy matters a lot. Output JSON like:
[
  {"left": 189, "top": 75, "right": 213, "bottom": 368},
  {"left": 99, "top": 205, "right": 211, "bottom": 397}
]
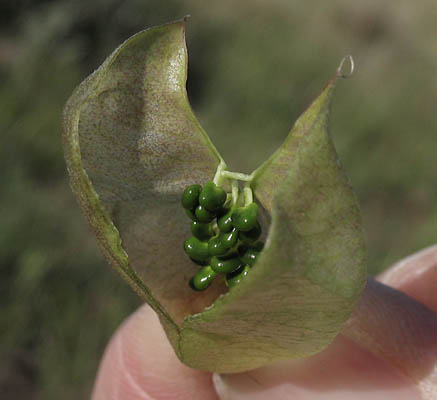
[{"left": 92, "top": 306, "right": 217, "bottom": 400}]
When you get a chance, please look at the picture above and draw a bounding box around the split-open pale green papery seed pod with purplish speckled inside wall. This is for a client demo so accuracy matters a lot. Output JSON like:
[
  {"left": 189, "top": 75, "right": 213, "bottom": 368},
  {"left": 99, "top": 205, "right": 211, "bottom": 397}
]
[{"left": 64, "top": 20, "right": 366, "bottom": 372}]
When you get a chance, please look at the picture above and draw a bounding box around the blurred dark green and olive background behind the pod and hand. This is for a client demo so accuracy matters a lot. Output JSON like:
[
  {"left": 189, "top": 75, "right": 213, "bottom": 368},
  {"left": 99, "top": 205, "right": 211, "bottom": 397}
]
[{"left": 0, "top": 0, "right": 437, "bottom": 400}]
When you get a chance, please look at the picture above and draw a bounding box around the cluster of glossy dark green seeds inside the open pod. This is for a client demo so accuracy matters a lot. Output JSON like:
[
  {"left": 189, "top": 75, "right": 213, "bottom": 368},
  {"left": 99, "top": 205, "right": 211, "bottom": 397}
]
[{"left": 182, "top": 181, "right": 263, "bottom": 290}]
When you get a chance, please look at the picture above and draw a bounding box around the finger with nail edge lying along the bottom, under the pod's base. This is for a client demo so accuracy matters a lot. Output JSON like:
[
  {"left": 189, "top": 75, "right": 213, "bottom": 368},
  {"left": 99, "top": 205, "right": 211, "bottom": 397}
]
[{"left": 213, "top": 335, "right": 420, "bottom": 400}]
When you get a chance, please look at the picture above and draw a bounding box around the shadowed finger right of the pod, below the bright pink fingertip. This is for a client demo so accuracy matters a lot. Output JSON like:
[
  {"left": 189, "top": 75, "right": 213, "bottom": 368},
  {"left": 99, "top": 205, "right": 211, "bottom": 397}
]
[{"left": 342, "top": 279, "right": 437, "bottom": 399}]
